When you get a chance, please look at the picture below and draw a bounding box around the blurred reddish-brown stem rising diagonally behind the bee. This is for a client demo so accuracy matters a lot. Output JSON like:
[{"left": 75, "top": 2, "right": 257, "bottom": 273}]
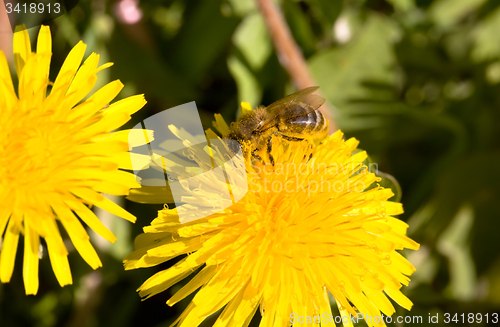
[{"left": 256, "top": 0, "right": 337, "bottom": 133}]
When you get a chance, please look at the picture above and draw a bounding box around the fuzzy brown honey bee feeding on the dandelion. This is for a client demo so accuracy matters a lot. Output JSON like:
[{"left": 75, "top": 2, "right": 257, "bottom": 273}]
[{"left": 225, "top": 86, "right": 328, "bottom": 164}]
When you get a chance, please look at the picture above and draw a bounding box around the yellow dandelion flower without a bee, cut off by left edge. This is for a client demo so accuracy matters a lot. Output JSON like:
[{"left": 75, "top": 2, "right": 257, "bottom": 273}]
[{"left": 0, "top": 26, "right": 151, "bottom": 294}]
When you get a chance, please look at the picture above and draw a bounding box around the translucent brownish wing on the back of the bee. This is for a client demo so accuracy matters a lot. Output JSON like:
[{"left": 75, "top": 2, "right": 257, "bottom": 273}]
[{"left": 265, "top": 86, "right": 325, "bottom": 121}]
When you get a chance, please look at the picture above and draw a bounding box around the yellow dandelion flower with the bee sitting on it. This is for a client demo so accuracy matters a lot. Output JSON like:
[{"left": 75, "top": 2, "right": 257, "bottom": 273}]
[{"left": 124, "top": 116, "right": 419, "bottom": 327}]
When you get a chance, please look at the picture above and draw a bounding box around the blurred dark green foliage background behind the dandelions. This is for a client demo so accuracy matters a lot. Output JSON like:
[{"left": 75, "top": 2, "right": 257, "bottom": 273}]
[{"left": 0, "top": 0, "right": 500, "bottom": 327}]
